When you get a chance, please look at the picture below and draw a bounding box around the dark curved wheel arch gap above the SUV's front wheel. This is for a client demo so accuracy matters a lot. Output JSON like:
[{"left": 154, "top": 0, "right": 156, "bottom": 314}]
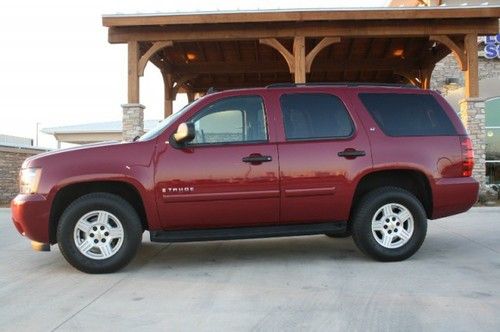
[{"left": 49, "top": 180, "right": 149, "bottom": 244}]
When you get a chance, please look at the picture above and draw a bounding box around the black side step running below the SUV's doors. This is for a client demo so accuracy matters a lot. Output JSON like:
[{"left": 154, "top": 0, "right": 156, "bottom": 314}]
[{"left": 149, "top": 221, "right": 347, "bottom": 242}]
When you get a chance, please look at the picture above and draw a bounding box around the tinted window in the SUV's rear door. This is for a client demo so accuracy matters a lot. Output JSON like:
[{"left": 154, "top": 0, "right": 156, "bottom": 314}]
[{"left": 280, "top": 93, "right": 353, "bottom": 140}]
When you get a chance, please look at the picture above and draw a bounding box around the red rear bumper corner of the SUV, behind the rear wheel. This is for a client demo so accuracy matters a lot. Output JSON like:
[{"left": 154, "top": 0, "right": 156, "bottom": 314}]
[{"left": 431, "top": 177, "right": 479, "bottom": 219}]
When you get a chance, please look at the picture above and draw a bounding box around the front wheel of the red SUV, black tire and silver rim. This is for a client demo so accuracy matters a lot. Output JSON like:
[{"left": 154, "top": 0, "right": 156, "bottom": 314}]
[{"left": 57, "top": 193, "right": 142, "bottom": 273}]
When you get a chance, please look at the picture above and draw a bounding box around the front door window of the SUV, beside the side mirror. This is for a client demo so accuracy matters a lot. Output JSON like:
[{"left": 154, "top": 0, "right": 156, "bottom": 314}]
[{"left": 191, "top": 96, "right": 267, "bottom": 144}]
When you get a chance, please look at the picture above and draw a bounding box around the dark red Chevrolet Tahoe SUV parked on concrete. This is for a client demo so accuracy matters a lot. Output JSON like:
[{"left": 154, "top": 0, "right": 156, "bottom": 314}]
[{"left": 12, "top": 84, "right": 478, "bottom": 273}]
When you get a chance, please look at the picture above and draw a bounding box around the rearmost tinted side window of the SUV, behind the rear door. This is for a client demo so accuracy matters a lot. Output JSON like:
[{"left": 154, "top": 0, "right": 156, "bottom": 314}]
[{"left": 359, "top": 93, "right": 457, "bottom": 136}]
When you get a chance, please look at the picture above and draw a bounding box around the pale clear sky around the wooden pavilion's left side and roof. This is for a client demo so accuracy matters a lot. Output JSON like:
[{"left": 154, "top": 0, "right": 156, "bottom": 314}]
[{"left": 0, "top": 0, "right": 387, "bottom": 148}]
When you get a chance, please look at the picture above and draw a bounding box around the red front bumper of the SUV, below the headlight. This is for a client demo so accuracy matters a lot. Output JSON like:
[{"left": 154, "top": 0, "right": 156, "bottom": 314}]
[{"left": 10, "top": 194, "right": 50, "bottom": 243}]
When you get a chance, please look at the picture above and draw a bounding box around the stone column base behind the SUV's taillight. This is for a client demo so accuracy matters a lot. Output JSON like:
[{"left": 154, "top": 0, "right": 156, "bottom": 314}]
[{"left": 460, "top": 98, "right": 486, "bottom": 187}]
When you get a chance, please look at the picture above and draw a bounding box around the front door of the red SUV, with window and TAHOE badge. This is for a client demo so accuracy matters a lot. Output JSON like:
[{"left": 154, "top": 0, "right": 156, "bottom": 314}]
[{"left": 155, "top": 95, "right": 280, "bottom": 229}]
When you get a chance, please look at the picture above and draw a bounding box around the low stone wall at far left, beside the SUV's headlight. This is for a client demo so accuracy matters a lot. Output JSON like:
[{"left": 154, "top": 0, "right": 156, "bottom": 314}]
[{"left": 0, "top": 146, "right": 45, "bottom": 205}]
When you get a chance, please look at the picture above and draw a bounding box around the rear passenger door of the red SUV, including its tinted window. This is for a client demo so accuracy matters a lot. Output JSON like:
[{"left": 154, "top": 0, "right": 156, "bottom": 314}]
[{"left": 275, "top": 88, "right": 372, "bottom": 223}]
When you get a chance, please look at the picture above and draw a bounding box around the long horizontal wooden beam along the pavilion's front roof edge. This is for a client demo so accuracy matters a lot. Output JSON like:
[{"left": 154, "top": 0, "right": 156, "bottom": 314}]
[{"left": 108, "top": 18, "right": 498, "bottom": 43}]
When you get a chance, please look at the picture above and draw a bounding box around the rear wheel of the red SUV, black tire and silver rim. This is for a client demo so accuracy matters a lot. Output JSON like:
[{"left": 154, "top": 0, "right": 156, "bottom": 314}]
[{"left": 352, "top": 187, "right": 427, "bottom": 262}]
